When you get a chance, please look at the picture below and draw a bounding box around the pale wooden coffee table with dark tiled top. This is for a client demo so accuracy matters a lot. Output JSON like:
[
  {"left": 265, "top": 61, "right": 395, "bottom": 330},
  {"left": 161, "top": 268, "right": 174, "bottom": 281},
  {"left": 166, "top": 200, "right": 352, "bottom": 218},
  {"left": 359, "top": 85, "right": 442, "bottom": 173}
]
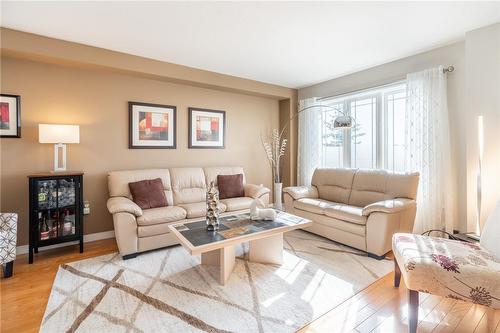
[{"left": 169, "top": 212, "right": 312, "bottom": 285}]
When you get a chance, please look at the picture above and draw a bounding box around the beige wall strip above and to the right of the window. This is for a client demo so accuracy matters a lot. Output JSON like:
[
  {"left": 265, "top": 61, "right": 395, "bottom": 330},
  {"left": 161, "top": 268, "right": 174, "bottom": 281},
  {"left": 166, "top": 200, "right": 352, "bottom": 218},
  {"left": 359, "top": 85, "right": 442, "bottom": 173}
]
[{"left": 299, "top": 42, "right": 467, "bottom": 230}]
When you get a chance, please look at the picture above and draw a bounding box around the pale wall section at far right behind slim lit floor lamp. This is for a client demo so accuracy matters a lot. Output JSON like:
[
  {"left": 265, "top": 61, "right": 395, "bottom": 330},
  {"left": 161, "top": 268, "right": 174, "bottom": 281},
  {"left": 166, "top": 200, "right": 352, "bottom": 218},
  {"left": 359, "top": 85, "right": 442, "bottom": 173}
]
[{"left": 464, "top": 23, "right": 500, "bottom": 231}]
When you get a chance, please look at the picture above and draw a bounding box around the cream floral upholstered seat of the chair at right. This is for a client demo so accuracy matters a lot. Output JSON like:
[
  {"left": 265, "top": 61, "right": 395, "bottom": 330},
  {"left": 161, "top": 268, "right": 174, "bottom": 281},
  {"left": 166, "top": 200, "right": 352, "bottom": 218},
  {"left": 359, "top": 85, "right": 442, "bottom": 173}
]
[{"left": 392, "top": 234, "right": 500, "bottom": 309}]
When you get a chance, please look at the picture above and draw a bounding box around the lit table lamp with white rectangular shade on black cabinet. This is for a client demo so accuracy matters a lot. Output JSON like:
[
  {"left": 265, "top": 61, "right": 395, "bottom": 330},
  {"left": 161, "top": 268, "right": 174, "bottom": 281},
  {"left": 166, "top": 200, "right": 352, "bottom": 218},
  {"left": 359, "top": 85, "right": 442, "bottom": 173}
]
[{"left": 38, "top": 124, "right": 80, "bottom": 172}]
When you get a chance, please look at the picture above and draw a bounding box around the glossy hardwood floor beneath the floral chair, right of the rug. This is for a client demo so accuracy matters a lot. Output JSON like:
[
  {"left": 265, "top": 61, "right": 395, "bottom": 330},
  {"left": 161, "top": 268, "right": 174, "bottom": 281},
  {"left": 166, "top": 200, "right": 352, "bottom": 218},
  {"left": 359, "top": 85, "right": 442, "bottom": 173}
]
[{"left": 299, "top": 273, "right": 500, "bottom": 333}]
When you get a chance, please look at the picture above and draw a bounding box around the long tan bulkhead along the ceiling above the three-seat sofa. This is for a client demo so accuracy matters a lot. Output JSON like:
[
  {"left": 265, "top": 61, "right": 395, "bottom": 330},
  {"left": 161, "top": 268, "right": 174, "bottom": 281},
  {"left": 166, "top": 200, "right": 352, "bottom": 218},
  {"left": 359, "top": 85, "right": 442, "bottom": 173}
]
[{"left": 0, "top": 27, "right": 296, "bottom": 99}]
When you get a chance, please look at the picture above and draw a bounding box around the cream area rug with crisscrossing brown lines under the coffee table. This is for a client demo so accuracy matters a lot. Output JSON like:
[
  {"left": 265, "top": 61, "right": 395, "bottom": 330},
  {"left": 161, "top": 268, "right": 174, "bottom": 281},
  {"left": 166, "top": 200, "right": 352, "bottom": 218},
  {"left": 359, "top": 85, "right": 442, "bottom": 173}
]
[{"left": 40, "top": 230, "right": 393, "bottom": 333}]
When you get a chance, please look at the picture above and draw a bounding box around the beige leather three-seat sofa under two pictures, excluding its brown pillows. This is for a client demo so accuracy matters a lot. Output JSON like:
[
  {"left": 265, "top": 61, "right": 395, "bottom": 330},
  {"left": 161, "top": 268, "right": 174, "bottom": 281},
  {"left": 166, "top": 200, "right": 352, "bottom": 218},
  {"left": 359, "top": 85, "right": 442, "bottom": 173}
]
[{"left": 107, "top": 167, "right": 269, "bottom": 259}]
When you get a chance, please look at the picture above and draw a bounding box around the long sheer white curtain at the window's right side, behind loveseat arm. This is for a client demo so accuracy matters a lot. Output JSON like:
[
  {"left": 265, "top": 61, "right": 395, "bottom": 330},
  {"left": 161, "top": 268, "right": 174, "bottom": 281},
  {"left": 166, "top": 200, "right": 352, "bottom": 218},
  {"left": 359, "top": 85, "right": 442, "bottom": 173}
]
[{"left": 405, "top": 66, "right": 455, "bottom": 233}]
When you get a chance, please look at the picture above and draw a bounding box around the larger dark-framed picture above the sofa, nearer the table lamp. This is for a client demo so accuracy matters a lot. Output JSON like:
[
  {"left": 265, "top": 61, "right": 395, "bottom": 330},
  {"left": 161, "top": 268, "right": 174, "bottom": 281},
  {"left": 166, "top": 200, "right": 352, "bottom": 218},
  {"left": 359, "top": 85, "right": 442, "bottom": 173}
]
[{"left": 128, "top": 102, "right": 177, "bottom": 149}]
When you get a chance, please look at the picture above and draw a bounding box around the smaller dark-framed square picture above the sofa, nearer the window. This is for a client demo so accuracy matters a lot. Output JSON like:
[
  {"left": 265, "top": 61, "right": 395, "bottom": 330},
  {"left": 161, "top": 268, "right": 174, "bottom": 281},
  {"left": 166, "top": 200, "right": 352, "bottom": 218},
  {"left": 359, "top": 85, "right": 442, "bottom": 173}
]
[{"left": 188, "top": 107, "right": 226, "bottom": 149}]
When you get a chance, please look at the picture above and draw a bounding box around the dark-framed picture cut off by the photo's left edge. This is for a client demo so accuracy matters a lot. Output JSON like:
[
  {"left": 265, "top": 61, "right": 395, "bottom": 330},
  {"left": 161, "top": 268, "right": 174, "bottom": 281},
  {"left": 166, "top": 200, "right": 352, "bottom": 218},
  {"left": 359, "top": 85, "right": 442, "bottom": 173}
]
[{"left": 0, "top": 94, "right": 21, "bottom": 138}]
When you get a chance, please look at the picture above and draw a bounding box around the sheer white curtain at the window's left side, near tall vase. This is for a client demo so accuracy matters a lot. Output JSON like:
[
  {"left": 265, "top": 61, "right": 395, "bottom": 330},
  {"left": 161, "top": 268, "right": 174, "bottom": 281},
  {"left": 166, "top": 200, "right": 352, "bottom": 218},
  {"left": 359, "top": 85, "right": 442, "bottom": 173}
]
[{"left": 297, "top": 98, "right": 322, "bottom": 186}]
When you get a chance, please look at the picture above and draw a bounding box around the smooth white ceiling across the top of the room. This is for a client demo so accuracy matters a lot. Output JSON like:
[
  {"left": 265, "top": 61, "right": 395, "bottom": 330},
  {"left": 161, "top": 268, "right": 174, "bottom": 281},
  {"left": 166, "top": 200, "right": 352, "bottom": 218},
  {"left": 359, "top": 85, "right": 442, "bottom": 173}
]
[{"left": 1, "top": 1, "right": 500, "bottom": 88}]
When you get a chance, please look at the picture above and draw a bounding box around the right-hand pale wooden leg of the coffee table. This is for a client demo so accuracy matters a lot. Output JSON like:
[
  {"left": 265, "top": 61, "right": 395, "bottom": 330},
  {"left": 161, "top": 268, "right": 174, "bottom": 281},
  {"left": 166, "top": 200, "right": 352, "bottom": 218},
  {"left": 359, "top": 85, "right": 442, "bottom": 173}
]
[{"left": 248, "top": 233, "right": 283, "bottom": 265}]
